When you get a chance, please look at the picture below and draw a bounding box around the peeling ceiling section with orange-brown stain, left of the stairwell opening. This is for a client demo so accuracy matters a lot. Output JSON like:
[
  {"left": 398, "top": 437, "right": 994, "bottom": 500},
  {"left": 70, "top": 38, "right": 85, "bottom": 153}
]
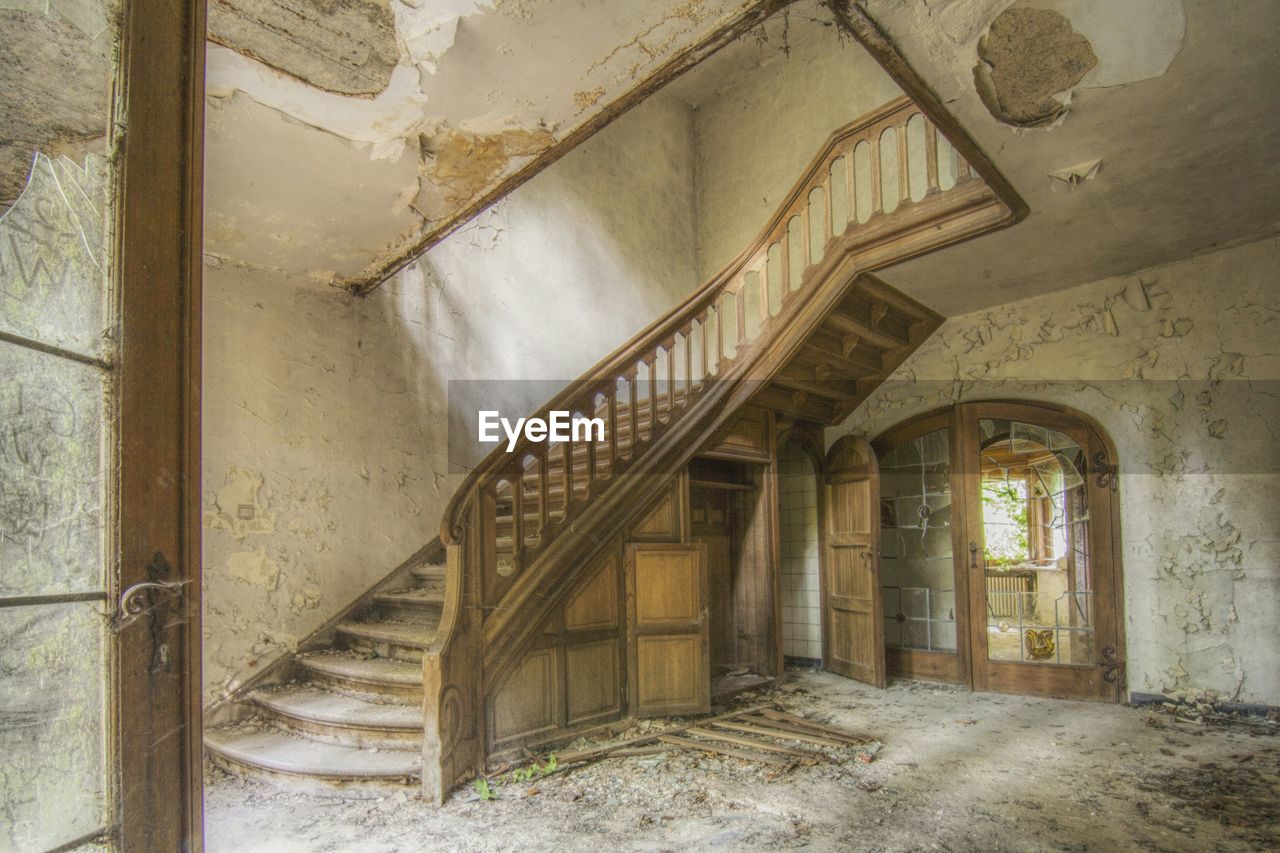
[{"left": 202, "top": 0, "right": 777, "bottom": 284}]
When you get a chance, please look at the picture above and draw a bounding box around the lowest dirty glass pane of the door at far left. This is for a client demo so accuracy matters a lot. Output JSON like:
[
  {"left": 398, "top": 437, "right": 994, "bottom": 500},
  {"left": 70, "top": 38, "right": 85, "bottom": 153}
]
[{"left": 0, "top": 602, "right": 106, "bottom": 850}]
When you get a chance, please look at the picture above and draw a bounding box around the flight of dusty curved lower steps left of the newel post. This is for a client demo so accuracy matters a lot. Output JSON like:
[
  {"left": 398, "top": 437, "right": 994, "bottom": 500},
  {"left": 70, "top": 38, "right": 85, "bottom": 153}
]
[{"left": 205, "top": 564, "right": 444, "bottom": 797}]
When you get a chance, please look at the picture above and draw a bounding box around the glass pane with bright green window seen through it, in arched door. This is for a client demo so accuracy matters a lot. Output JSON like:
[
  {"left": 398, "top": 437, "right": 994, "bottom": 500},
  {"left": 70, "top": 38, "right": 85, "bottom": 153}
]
[{"left": 979, "top": 420, "right": 1094, "bottom": 665}]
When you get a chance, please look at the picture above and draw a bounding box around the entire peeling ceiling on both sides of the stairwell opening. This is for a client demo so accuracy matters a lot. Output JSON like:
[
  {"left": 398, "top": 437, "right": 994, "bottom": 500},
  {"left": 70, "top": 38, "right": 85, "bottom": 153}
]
[{"left": 202, "top": 0, "right": 1280, "bottom": 314}]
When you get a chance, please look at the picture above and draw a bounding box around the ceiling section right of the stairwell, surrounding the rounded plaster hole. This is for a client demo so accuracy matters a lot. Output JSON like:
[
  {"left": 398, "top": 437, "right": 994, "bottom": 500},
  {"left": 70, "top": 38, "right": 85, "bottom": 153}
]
[{"left": 861, "top": 0, "right": 1280, "bottom": 315}]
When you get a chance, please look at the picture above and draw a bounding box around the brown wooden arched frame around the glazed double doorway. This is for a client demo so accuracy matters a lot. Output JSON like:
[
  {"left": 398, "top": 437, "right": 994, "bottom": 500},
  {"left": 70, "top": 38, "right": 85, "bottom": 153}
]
[{"left": 872, "top": 398, "right": 1128, "bottom": 702}]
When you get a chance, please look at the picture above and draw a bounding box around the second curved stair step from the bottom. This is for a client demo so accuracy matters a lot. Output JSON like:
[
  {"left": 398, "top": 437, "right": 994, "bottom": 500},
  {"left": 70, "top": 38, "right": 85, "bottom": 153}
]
[{"left": 252, "top": 684, "right": 422, "bottom": 749}]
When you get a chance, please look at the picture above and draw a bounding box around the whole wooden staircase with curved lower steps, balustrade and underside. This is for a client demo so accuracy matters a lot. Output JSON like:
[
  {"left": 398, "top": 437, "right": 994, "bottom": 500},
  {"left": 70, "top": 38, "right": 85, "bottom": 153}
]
[{"left": 206, "top": 97, "right": 1025, "bottom": 802}]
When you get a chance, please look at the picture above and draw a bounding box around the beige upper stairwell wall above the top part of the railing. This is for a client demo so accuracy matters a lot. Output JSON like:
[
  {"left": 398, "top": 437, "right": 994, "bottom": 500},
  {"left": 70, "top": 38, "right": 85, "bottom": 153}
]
[{"left": 694, "top": 11, "right": 901, "bottom": 282}]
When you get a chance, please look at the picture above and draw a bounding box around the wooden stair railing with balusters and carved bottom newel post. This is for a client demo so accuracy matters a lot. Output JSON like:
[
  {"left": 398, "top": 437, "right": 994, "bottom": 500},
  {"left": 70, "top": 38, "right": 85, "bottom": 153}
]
[{"left": 424, "top": 97, "right": 1015, "bottom": 800}]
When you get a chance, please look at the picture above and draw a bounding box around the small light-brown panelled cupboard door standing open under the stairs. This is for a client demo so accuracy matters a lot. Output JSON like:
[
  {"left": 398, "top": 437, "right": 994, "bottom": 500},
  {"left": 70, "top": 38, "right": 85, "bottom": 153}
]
[{"left": 627, "top": 543, "right": 712, "bottom": 717}]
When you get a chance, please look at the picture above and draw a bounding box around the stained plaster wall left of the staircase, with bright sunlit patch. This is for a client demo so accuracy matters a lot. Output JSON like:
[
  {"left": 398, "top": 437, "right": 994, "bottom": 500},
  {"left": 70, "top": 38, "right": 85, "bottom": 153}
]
[{"left": 204, "top": 96, "right": 696, "bottom": 701}]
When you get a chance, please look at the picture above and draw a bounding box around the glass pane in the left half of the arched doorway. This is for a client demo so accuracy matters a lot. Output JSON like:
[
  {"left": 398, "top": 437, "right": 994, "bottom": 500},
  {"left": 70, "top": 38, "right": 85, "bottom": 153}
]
[{"left": 879, "top": 429, "right": 956, "bottom": 653}]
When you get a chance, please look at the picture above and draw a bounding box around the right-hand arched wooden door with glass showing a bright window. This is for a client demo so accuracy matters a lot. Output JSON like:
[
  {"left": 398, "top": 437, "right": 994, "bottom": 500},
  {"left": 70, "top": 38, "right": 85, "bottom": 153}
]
[{"left": 959, "top": 402, "right": 1124, "bottom": 702}]
